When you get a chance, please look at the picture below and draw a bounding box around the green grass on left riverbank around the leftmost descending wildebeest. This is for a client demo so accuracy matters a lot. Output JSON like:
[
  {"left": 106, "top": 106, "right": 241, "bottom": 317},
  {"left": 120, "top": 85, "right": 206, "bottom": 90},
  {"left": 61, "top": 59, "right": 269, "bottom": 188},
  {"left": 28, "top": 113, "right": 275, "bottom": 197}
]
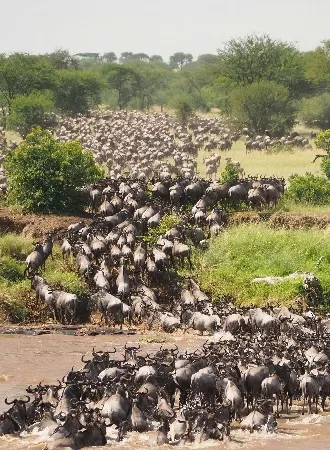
[{"left": 0, "top": 233, "right": 84, "bottom": 323}]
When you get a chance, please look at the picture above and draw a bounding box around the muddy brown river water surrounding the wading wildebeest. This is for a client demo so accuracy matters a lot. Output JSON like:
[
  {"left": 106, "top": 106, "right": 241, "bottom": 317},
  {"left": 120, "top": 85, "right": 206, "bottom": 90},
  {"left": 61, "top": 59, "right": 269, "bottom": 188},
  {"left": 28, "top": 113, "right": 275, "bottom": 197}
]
[{"left": 0, "top": 333, "right": 330, "bottom": 450}]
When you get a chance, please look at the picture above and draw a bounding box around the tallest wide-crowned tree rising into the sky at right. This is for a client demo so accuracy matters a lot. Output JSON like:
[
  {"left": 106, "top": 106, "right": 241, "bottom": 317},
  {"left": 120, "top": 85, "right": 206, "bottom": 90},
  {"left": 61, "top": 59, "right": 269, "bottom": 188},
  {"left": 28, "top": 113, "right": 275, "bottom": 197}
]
[{"left": 218, "top": 34, "right": 308, "bottom": 96}]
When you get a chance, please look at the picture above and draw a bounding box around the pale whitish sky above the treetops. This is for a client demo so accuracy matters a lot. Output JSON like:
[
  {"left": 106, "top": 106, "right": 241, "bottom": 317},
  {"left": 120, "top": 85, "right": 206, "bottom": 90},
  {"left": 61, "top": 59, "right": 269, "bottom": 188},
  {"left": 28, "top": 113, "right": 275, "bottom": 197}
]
[{"left": 0, "top": 0, "right": 330, "bottom": 60}]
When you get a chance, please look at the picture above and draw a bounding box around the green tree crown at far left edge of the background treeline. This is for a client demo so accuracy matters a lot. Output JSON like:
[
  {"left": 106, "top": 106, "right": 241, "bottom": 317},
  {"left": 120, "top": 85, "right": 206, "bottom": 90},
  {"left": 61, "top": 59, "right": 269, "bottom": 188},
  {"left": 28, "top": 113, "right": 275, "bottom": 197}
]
[{"left": 0, "top": 53, "right": 56, "bottom": 112}]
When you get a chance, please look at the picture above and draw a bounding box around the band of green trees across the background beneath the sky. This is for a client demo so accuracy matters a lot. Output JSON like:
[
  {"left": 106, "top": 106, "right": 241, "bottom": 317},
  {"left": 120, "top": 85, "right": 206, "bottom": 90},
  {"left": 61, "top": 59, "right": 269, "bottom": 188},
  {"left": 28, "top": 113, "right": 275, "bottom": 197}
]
[{"left": 0, "top": 35, "right": 330, "bottom": 133}]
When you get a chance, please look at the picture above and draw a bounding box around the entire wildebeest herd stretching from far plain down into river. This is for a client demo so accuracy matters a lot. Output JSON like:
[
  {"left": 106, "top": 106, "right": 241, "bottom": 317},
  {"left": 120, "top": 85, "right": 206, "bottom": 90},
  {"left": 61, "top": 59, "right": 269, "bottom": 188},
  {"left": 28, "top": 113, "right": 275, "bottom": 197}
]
[{"left": 0, "top": 111, "right": 330, "bottom": 449}]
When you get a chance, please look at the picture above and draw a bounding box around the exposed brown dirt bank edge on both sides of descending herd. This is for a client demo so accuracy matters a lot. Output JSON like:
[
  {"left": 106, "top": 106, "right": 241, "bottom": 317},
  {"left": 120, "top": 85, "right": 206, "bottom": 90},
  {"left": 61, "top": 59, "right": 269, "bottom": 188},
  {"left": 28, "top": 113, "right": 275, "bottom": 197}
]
[{"left": 0, "top": 208, "right": 330, "bottom": 238}]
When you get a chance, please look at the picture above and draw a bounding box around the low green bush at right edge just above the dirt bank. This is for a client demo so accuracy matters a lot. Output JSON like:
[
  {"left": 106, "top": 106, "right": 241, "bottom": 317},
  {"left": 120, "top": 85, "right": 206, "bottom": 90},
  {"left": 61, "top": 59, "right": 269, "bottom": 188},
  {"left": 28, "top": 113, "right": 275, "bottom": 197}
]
[{"left": 286, "top": 172, "right": 330, "bottom": 205}]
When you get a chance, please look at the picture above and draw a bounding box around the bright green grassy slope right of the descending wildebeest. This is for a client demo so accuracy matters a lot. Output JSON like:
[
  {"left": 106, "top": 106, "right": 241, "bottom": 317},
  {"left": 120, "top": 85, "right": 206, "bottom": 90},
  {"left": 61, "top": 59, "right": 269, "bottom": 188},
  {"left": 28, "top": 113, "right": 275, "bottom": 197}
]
[{"left": 186, "top": 224, "right": 330, "bottom": 306}]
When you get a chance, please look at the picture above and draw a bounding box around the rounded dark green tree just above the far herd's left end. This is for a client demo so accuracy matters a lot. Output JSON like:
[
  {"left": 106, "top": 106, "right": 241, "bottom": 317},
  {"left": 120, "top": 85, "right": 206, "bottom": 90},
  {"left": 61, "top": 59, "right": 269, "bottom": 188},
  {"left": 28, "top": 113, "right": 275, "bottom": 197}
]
[{"left": 54, "top": 70, "right": 102, "bottom": 115}]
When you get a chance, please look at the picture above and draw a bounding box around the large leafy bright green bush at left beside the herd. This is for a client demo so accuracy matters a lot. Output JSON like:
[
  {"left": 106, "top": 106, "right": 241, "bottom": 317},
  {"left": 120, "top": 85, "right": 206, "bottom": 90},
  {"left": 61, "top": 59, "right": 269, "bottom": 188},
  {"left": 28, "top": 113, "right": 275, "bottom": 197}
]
[{"left": 5, "top": 128, "right": 102, "bottom": 213}]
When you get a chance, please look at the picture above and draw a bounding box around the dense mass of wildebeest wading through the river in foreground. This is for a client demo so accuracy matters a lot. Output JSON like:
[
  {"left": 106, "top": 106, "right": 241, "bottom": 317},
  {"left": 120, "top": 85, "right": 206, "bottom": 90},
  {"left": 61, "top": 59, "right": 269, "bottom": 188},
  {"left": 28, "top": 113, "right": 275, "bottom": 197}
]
[{"left": 0, "top": 308, "right": 330, "bottom": 450}]
